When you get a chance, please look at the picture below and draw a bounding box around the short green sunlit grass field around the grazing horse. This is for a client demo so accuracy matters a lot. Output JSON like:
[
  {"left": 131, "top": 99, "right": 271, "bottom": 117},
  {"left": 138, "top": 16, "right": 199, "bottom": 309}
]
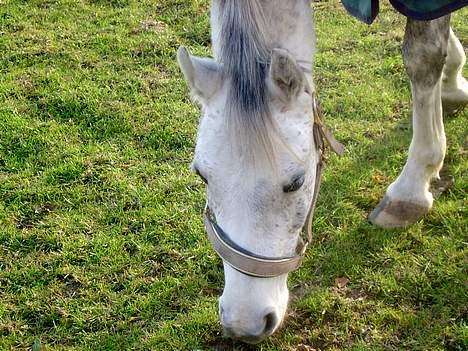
[{"left": 0, "top": 0, "right": 468, "bottom": 351}]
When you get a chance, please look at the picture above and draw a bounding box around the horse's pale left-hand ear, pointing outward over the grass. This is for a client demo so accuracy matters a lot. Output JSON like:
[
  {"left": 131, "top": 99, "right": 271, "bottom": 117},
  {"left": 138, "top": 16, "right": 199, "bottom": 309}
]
[{"left": 177, "top": 46, "right": 221, "bottom": 103}]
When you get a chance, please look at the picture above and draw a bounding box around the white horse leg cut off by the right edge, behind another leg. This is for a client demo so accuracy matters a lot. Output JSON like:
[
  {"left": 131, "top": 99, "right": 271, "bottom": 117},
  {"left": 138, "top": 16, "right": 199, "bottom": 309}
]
[{"left": 442, "top": 29, "right": 468, "bottom": 114}]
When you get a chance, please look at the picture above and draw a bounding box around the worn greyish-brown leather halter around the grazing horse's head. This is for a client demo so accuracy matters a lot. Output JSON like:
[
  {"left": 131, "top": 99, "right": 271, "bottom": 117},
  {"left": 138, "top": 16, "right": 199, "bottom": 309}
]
[{"left": 203, "top": 93, "right": 344, "bottom": 278}]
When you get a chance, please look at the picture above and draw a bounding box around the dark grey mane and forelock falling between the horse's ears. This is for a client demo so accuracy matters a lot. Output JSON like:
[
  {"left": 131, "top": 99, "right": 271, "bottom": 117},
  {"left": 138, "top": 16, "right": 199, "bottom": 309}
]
[{"left": 219, "top": 0, "right": 272, "bottom": 160}]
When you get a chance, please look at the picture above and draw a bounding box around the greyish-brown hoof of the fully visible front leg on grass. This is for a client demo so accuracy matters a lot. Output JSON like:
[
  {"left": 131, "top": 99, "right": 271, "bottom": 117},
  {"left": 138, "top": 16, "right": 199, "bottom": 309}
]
[{"left": 368, "top": 195, "right": 431, "bottom": 229}]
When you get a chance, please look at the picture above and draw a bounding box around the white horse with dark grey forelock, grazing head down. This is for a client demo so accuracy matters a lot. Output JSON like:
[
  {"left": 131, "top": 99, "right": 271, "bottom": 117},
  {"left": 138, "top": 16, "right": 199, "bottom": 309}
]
[{"left": 178, "top": 0, "right": 468, "bottom": 343}]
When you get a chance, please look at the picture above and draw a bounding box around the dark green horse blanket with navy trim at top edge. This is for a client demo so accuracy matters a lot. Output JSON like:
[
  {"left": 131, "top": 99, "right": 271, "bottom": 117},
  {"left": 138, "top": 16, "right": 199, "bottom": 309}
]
[{"left": 342, "top": 0, "right": 468, "bottom": 24}]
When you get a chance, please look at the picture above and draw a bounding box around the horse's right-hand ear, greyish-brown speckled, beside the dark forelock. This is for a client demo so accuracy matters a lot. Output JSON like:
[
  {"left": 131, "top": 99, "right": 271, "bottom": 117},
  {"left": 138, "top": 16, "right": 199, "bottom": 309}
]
[{"left": 269, "top": 49, "right": 305, "bottom": 104}]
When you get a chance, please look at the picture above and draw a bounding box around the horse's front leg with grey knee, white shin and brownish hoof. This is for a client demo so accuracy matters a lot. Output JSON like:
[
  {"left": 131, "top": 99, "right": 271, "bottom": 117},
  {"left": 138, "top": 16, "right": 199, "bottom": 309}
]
[{"left": 369, "top": 16, "right": 450, "bottom": 228}]
